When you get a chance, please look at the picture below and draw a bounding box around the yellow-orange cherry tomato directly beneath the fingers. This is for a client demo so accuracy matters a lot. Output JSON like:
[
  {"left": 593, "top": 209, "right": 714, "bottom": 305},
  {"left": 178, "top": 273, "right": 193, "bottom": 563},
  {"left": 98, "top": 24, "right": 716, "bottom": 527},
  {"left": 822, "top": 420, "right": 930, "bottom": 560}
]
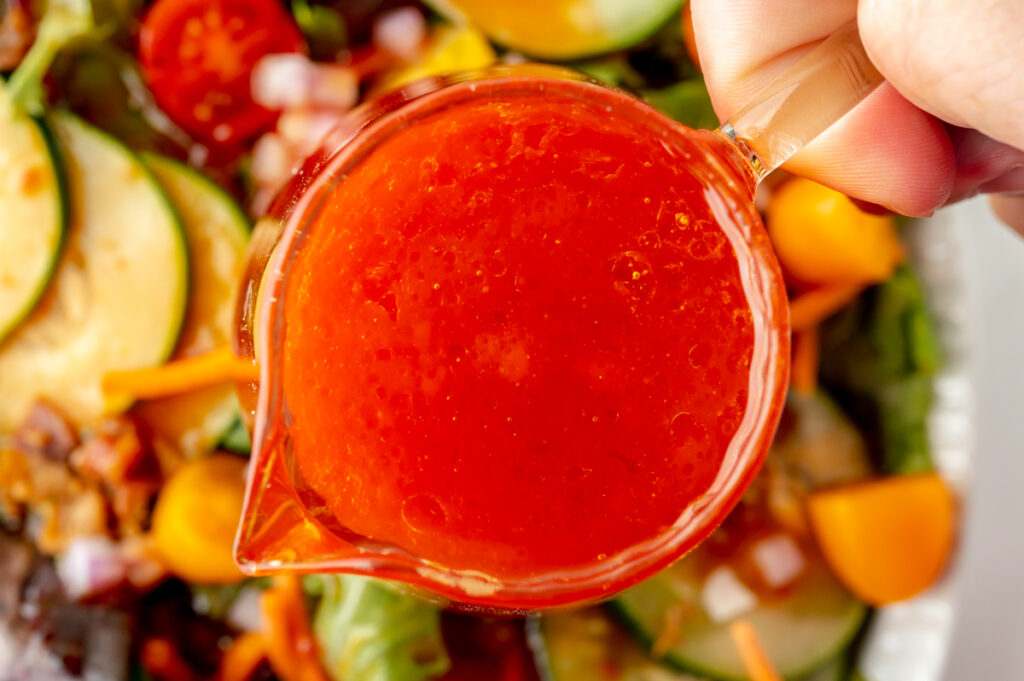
[{"left": 766, "top": 177, "right": 905, "bottom": 285}]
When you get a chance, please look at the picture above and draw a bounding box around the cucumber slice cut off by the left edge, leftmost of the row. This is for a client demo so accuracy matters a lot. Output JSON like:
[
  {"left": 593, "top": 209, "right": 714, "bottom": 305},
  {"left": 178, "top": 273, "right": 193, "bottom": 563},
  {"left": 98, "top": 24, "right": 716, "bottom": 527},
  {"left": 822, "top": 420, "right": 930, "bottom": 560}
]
[{"left": 0, "top": 83, "right": 68, "bottom": 343}]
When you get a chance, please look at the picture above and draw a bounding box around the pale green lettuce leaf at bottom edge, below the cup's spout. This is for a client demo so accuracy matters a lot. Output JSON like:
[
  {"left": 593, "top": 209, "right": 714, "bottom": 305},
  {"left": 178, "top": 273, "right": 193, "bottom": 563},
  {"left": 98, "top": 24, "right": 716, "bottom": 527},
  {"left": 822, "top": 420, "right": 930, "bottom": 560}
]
[{"left": 313, "top": 576, "right": 450, "bottom": 681}]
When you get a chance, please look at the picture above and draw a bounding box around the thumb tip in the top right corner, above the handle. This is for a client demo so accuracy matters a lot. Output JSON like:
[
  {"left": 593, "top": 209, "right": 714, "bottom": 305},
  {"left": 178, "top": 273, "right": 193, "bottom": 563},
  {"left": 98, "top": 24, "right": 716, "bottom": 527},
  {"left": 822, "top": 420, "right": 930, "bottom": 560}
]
[{"left": 858, "top": 0, "right": 1024, "bottom": 150}]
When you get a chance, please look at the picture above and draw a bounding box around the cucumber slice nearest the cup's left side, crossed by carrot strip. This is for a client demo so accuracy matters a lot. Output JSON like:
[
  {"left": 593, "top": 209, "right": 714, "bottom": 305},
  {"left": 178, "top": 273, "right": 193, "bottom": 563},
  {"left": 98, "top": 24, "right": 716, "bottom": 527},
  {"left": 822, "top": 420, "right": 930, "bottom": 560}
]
[{"left": 135, "top": 154, "right": 249, "bottom": 456}]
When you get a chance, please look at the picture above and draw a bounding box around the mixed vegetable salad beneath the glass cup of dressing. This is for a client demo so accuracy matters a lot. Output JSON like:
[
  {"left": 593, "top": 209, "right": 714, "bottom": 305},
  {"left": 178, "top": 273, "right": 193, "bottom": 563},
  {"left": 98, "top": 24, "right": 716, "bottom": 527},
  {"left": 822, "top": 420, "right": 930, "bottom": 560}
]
[{"left": 0, "top": 0, "right": 956, "bottom": 681}]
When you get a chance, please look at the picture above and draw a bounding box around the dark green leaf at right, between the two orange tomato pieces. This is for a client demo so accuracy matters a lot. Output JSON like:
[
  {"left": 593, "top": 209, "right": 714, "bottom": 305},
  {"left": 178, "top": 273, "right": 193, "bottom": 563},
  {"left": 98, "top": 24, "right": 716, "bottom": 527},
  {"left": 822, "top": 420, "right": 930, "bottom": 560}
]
[{"left": 821, "top": 266, "right": 940, "bottom": 474}]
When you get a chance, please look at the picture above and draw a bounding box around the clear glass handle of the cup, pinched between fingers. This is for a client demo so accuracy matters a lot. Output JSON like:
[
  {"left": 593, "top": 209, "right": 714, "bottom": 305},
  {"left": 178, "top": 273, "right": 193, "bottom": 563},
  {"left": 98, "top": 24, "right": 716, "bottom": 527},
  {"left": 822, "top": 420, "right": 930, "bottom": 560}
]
[{"left": 721, "top": 22, "right": 884, "bottom": 179}]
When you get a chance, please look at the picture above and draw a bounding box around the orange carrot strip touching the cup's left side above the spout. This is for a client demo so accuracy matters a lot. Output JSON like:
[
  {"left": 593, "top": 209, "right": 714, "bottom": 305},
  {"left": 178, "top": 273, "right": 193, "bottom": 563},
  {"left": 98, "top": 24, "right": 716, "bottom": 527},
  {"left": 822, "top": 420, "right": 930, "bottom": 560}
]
[{"left": 103, "top": 347, "right": 259, "bottom": 398}]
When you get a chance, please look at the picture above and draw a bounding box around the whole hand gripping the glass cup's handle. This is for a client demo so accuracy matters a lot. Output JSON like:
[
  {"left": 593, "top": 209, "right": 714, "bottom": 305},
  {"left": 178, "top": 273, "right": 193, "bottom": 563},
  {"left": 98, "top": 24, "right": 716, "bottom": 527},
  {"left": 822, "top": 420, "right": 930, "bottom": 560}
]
[{"left": 691, "top": 0, "right": 1024, "bottom": 231}]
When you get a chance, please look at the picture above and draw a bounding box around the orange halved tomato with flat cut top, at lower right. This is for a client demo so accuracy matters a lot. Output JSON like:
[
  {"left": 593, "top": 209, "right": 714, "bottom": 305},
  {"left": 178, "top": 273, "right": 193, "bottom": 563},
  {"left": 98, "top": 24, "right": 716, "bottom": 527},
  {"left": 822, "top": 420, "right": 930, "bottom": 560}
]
[{"left": 808, "top": 473, "right": 955, "bottom": 605}]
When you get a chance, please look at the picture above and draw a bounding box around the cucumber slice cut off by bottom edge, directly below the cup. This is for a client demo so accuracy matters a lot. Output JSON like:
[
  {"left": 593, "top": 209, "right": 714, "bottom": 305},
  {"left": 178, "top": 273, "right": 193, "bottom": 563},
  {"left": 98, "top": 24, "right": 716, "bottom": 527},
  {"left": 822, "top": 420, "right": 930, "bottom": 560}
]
[{"left": 526, "top": 607, "right": 699, "bottom": 681}]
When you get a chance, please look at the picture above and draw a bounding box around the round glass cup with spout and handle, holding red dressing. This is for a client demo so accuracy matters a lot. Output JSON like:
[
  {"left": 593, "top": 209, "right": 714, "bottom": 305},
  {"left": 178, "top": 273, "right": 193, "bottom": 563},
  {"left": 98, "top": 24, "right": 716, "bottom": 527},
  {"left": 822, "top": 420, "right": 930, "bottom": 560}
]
[{"left": 236, "top": 22, "right": 884, "bottom": 610}]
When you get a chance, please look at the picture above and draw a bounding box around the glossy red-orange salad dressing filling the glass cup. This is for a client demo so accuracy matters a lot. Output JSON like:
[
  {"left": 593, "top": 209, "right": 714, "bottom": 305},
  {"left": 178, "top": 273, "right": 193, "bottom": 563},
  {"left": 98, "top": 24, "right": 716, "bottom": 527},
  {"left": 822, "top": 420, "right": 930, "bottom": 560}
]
[{"left": 235, "top": 73, "right": 785, "bottom": 606}]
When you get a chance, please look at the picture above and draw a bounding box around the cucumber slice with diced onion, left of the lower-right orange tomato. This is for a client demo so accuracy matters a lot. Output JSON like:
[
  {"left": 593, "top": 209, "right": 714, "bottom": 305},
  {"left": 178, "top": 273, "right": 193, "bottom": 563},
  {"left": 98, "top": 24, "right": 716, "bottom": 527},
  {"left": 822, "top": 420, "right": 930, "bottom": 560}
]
[{"left": 614, "top": 549, "right": 867, "bottom": 681}]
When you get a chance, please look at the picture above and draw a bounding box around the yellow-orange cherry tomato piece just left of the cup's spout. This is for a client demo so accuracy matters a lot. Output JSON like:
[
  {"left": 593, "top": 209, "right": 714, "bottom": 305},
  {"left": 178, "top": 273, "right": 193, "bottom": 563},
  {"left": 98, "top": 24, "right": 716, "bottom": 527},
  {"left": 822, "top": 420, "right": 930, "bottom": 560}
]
[{"left": 152, "top": 455, "right": 246, "bottom": 584}]
